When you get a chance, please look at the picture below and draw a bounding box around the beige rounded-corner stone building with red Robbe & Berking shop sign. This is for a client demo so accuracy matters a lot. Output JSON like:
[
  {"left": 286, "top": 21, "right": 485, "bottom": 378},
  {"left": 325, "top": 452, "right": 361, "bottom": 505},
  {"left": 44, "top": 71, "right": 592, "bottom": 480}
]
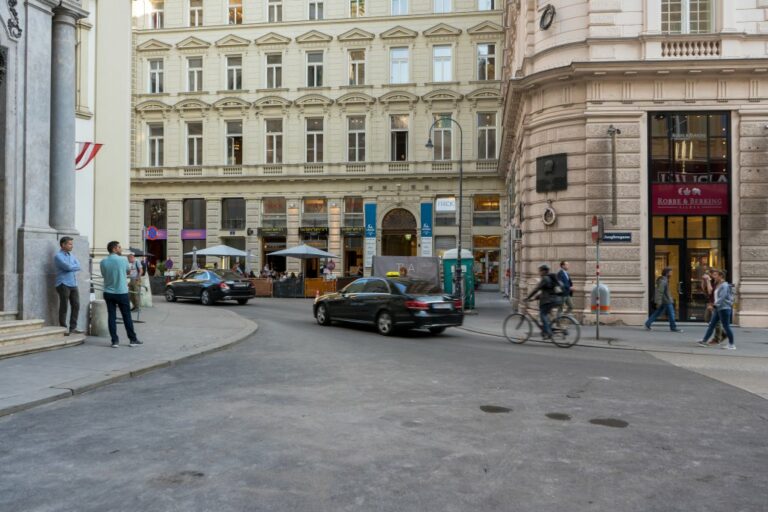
[{"left": 499, "top": 0, "right": 768, "bottom": 327}]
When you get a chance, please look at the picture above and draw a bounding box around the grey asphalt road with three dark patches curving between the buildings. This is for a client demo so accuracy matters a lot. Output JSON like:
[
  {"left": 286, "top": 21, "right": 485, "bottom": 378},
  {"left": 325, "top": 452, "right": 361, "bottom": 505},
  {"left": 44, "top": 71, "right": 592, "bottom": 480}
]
[{"left": 0, "top": 299, "right": 768, "bottom": 512}]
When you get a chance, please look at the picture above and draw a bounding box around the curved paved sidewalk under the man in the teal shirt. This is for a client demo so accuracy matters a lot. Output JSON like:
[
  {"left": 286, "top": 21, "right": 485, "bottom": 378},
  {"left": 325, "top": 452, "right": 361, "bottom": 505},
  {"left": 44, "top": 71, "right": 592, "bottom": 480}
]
[{"left": 0, "top": 298, "right": 258, "bottom": 416}]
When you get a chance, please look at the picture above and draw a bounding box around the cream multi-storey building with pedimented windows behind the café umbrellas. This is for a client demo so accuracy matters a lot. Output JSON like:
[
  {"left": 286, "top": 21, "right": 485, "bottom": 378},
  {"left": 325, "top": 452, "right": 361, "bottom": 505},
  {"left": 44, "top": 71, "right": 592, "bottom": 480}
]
[{"left": 131, "top": 0, "right": 507, "bottom": 286}]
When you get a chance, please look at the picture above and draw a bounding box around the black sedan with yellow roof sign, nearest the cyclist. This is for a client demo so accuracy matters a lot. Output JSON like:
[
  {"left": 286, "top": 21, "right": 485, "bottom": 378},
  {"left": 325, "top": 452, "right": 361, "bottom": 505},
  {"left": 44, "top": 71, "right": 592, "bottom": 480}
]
[{"left": 313, "top": 277, "right": 464, "bottom": 336}]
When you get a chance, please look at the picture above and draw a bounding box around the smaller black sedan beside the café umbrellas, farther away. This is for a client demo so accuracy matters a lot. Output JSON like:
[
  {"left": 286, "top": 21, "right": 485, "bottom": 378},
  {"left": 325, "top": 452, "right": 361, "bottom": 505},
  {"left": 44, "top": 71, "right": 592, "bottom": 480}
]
[{"left": 165, "top": 269, "right": 256, "bottom": 306}]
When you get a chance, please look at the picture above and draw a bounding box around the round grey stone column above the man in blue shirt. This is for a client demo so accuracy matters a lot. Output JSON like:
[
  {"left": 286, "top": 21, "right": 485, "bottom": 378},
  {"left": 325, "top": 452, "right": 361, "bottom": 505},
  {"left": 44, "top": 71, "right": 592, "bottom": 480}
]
[{"left": 50, "top": 2, "right": 85, "bottom": 233}]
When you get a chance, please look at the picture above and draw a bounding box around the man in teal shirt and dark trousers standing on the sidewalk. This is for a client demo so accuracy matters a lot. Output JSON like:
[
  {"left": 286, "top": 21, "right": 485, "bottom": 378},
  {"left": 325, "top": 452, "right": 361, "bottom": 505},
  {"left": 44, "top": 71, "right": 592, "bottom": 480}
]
[{"left": 99, "top": 241, "right": 142, "bottom": 348}]
